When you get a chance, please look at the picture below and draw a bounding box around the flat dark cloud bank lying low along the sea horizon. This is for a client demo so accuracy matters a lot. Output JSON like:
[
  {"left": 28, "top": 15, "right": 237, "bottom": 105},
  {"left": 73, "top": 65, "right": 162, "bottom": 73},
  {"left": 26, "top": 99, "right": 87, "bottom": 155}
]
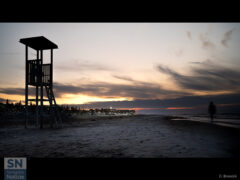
[{"left": 80, "top": 94, "right": 240, "bottom": 113}]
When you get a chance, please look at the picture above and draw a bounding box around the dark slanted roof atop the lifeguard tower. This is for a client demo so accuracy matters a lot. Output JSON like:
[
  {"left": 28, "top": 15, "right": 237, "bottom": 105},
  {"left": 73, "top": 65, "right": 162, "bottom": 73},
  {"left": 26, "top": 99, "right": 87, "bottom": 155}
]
[{"left": 19, "top": 36, "right": 58, "bottom": 50}]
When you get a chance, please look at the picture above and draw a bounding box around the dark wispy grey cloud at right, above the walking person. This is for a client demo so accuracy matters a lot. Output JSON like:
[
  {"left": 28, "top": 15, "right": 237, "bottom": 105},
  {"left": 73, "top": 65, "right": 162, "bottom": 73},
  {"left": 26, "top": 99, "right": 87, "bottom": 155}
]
[{"left": 158, "top": 61, "right": 240, "bottom": 91}]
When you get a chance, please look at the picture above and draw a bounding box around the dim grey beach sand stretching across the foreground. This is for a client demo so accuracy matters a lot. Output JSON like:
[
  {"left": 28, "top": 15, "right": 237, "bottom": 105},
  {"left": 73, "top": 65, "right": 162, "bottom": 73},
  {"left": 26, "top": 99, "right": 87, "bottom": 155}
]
[{"left": 0, "top": 115, "right": 240, "bottom": 158}]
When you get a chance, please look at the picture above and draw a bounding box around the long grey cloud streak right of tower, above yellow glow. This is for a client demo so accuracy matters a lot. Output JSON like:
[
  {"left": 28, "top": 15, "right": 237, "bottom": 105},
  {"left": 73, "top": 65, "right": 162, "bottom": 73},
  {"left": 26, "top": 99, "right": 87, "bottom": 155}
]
[{"left": 54, "top": 81, "right": 188, "bottom": 99}]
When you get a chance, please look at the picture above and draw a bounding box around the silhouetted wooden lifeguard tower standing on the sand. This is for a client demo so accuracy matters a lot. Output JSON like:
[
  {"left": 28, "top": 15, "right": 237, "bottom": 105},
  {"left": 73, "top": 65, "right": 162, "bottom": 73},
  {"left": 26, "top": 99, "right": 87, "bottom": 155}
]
[{"left": 19, "top": 36, "right": 62, "bottom": 128}]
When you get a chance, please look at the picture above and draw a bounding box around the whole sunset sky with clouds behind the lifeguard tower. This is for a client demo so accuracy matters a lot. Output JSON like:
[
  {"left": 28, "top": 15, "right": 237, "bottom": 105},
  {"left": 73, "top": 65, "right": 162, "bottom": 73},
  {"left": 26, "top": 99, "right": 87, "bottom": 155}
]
[{"left": 0, "top": 23, "right": 240, "bottom": 112}]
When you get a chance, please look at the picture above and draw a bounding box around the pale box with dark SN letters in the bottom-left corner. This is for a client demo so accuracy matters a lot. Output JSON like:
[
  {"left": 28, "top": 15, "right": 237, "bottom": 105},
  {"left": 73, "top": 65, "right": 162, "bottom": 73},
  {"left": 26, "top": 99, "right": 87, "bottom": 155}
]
[{"left": 4, "top": 158, "right": 26, "bottom": 169}]
